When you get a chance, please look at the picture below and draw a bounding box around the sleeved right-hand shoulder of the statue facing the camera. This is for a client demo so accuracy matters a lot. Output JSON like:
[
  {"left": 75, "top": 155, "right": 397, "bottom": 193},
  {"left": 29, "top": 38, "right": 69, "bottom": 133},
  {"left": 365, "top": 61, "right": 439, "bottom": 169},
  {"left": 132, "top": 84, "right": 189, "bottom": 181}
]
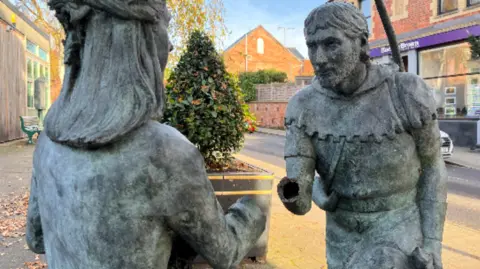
[{"left": 394, "top": 72, "right": 437, "bottom": 128}]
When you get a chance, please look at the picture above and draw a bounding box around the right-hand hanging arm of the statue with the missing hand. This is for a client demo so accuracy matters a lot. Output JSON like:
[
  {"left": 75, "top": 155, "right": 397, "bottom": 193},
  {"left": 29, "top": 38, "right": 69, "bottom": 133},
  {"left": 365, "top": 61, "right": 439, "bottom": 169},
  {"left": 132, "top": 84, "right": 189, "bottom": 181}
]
[{"left": 396, "top": 73, "right": 447, "bottom": 244}]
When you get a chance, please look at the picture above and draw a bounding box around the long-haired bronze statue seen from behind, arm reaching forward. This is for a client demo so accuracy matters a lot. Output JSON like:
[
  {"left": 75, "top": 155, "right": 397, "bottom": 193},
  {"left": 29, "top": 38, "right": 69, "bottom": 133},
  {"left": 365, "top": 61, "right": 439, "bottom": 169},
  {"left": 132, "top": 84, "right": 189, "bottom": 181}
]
[{"left": 26, "top": 0, "right": 266, "bottom": 269}]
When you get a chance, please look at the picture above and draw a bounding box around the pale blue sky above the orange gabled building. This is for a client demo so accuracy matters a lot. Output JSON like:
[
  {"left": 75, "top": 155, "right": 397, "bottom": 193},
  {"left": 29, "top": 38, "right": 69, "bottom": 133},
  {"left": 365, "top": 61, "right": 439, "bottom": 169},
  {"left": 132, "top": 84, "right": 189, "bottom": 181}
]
[{"left": 223, "top": 0, "right": 326, "bottom": 58}]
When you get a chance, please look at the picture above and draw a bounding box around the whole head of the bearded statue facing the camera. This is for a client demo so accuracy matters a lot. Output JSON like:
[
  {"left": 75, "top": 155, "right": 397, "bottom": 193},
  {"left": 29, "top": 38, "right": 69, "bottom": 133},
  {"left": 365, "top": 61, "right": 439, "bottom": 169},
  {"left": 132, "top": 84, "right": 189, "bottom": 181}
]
[{"left": 304, "top": 2, "right": 370, "bottom": 89}]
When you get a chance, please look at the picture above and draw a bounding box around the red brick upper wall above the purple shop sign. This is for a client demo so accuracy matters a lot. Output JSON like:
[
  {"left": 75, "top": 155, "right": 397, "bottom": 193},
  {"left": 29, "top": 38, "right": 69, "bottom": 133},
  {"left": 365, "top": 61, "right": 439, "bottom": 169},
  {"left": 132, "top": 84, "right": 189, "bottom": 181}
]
[{"left": 370, "top": 0, "right": 480, "bottom": 41}]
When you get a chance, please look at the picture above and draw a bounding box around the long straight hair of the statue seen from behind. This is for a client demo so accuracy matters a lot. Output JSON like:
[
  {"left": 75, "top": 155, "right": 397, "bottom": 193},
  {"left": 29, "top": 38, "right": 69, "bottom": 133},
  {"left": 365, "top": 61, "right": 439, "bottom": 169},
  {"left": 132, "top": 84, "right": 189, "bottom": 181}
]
[{"left": 45, "top": 0, "right": 168, "bottom": 148}]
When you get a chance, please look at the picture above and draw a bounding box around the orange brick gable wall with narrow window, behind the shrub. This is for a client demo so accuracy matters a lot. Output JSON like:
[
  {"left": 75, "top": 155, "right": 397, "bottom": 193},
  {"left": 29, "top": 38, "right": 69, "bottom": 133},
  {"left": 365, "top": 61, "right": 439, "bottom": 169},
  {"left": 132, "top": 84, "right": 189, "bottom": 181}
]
[{"left": 223, "top": 26, "right": 302, "bottom": 81}]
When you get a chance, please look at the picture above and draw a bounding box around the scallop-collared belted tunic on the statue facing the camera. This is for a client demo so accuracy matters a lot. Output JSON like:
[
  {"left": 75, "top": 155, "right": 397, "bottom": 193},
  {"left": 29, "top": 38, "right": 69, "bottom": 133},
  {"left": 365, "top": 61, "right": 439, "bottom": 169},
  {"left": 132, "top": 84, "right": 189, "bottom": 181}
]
[{"left": 285, "top": 65, "right": 436, "bottom": 269}]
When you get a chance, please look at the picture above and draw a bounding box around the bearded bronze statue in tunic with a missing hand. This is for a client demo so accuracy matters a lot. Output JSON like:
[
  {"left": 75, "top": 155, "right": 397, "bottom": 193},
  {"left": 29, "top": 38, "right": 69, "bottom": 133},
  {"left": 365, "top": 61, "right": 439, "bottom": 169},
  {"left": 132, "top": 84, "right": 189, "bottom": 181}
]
[{"left": 278, "top": 2, "right": 447, "bottom": 269}]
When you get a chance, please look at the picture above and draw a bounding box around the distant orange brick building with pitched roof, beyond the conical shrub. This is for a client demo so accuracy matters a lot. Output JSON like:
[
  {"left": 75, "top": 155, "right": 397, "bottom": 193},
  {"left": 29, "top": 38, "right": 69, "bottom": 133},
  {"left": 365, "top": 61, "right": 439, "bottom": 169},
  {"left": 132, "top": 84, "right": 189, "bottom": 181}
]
[{"left": 223, "top": 25, "right": 313, "bottom": 81}]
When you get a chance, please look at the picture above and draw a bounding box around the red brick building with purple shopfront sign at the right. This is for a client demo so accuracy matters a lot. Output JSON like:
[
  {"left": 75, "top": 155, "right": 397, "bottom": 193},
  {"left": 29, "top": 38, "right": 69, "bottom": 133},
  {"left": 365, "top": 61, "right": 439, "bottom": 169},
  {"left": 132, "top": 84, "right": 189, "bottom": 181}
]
[{"left": 354, "top": 0, "right": 480, "bottom": 146}]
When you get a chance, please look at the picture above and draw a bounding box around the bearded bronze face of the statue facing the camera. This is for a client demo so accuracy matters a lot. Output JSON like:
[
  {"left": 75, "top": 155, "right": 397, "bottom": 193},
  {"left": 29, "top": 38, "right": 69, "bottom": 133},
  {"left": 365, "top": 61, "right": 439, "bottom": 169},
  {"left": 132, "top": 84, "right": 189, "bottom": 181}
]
[{"left": 307, "top": 27, "right": 361, "bottom": 90}]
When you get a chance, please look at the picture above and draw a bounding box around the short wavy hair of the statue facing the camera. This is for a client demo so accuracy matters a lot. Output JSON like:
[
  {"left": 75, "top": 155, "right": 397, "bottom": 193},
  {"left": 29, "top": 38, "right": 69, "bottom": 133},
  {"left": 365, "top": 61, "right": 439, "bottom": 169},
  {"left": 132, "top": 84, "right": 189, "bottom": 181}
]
[{"left": 304, "top": 2, "right": 370, "bottom": 65}]
